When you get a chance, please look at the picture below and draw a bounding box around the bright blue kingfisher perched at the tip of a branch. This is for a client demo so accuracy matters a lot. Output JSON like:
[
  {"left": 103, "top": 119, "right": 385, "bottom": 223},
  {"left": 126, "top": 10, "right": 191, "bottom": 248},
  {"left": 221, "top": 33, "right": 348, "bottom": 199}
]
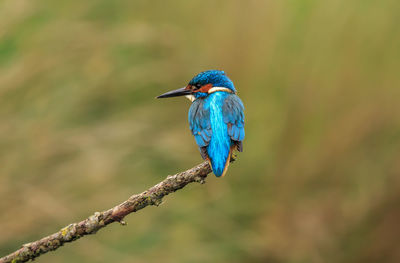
[{"left": 157, "top": 70, "right": 244, "bottom": 177}]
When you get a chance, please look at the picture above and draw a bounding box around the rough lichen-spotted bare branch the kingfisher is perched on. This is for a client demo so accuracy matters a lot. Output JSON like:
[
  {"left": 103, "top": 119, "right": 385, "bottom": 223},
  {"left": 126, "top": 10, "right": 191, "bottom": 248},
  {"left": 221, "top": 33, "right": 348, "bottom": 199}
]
[{"left": 0, "top": 162, "right": 216, "bottom": 263}]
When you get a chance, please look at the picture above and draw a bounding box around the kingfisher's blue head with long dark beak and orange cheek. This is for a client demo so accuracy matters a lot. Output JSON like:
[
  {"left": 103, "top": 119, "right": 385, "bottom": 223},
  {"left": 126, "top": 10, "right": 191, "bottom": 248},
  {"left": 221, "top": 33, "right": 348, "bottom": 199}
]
[{"left": 157, "top": 70, "right": 236, "bottom": 101}]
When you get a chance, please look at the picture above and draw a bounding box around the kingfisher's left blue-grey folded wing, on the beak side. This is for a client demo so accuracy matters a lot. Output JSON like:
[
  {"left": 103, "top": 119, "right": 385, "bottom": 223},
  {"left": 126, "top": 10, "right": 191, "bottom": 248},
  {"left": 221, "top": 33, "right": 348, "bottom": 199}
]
[{"left": 189, "top": 99, "right": 212, "bottom": 148}]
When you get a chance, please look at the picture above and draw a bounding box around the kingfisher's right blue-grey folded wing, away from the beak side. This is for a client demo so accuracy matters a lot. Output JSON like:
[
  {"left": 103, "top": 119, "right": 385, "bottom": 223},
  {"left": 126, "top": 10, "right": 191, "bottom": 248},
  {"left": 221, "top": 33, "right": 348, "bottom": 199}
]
[{"left": 222, "top": 94, "right": 244, "bottom": 151}]
